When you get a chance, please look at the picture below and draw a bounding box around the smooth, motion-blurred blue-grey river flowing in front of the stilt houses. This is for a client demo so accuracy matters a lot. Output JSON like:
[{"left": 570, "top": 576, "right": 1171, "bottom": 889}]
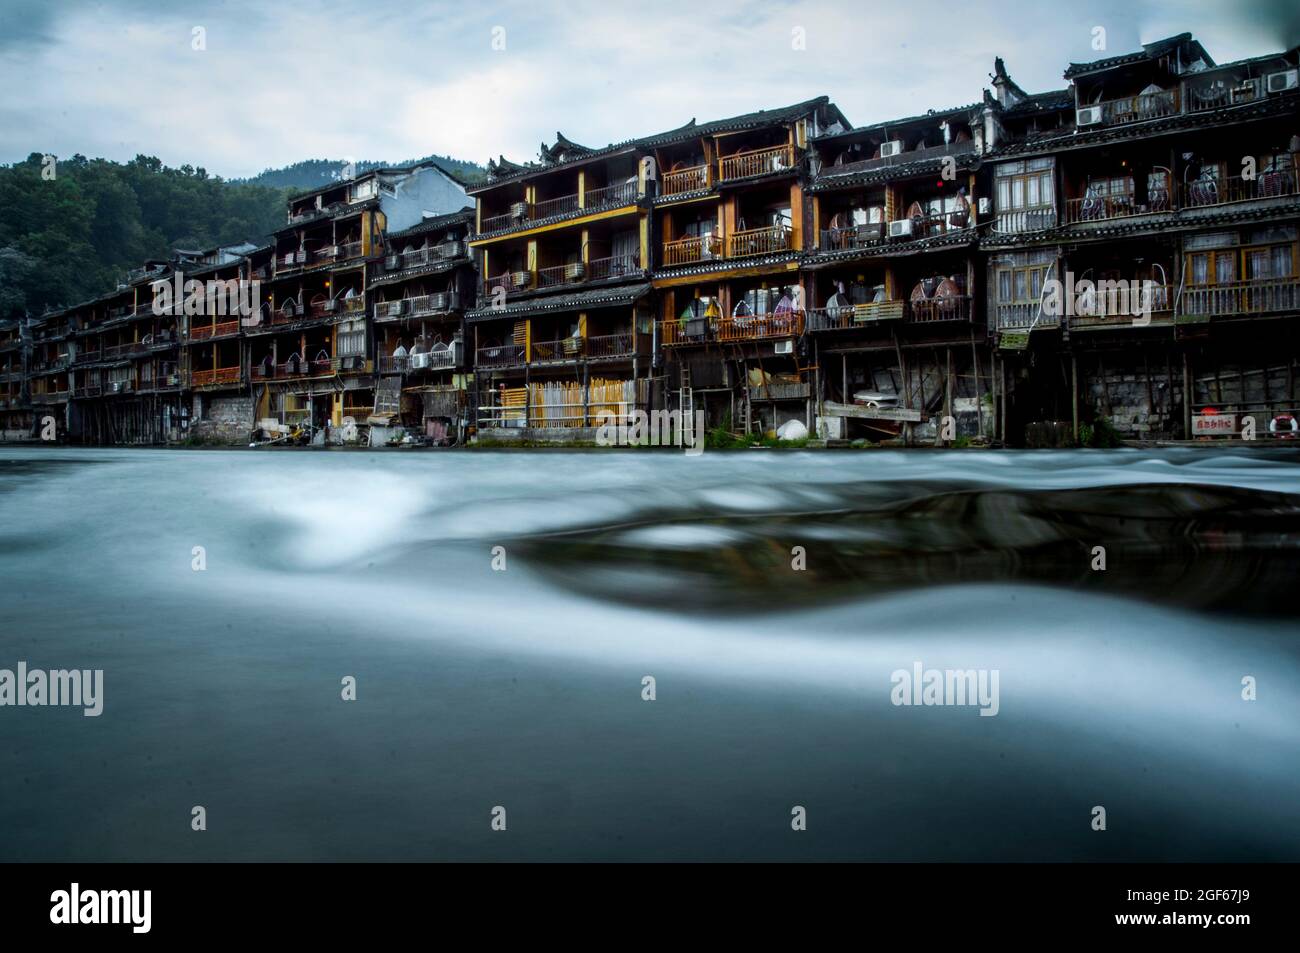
[{"left": 0, "top": 447, "right": 1300, "bottom": 861}]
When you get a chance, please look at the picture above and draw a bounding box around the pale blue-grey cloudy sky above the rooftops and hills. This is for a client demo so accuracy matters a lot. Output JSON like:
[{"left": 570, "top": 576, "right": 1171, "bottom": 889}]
[{"left": 0, "top": 0, "right": 1300, "bottom": 177}]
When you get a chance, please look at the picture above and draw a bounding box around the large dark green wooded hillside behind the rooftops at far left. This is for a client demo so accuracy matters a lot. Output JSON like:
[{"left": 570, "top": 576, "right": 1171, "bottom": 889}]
[{"left": 0, "top": 153, "right": 287, "bottom": 319}]
